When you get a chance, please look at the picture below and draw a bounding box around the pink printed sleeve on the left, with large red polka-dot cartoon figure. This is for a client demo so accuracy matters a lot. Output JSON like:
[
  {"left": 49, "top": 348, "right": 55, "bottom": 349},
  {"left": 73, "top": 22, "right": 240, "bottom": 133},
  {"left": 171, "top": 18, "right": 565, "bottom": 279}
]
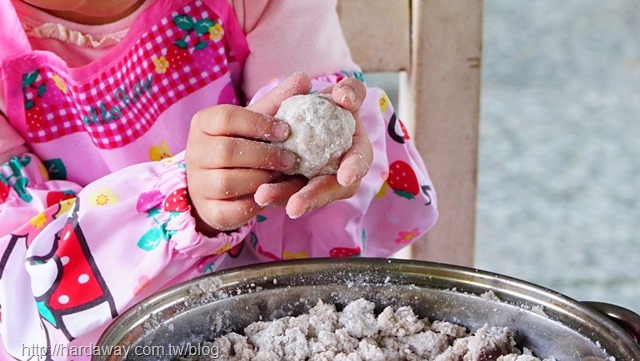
[{"left": 0, "top": 152, "right": 254, "bottom": 357}]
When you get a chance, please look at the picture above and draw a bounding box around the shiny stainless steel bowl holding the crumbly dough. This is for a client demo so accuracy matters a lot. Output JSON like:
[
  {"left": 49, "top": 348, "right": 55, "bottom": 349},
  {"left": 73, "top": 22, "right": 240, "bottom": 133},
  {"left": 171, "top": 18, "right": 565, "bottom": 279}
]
[{"left": 94, "top": 258, "right": 640, "bottom": 361}]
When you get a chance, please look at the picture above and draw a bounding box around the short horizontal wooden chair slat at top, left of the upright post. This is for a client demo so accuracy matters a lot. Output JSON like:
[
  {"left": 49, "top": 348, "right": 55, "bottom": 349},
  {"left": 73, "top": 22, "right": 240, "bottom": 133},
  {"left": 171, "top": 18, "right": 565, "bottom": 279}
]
[{"left": 336, "top": 0, "right": 411, "bottom": 72}]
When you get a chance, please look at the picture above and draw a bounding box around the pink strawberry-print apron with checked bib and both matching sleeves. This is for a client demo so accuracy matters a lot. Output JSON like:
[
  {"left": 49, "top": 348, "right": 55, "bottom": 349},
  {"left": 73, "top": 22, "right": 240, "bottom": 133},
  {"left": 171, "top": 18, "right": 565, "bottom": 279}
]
[{"left": 0, "top": 0, "right": 438, "bottom": 361}]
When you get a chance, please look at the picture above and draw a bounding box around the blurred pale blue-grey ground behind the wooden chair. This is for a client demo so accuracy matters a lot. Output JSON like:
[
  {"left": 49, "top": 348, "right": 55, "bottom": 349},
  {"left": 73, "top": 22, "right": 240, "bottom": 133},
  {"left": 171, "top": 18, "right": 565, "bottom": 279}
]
[{"left": 367, "top": 0, "right": 640, "bottom": 312}]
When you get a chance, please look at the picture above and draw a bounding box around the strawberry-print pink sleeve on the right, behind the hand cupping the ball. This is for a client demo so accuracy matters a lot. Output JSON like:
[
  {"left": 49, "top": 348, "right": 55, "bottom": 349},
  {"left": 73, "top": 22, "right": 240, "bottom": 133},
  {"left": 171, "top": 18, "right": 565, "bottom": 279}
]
[{"left": 251, "top": 72, "right": 438, "bottom": 260}]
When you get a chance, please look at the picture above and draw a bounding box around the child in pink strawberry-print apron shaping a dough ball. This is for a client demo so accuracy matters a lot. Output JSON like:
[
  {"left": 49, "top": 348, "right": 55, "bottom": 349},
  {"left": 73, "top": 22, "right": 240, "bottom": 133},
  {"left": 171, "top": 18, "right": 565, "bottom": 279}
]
[{"left": 0, "top": 0, "right": 437, "bottom": 360}]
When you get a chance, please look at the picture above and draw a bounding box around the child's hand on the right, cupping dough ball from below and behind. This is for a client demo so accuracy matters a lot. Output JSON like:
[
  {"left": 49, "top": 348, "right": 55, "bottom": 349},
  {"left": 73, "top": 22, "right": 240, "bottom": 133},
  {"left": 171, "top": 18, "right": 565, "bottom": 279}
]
[{"left": 254, "top": 74, "right": 373, "bottom": 218}]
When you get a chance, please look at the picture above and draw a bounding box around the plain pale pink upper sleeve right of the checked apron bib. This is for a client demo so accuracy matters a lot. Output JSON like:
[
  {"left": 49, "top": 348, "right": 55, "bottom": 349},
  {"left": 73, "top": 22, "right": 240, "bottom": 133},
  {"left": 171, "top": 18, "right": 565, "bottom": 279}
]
[{"left": 232, "top": 0, "right": 360, "bottom": 99}]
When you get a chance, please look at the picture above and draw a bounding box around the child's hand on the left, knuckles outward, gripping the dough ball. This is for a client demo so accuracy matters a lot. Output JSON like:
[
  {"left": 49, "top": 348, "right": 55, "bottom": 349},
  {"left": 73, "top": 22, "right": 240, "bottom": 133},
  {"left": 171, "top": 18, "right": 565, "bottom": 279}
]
[{"left": 185, "top": 76, "right": 310, "bottom": 237}]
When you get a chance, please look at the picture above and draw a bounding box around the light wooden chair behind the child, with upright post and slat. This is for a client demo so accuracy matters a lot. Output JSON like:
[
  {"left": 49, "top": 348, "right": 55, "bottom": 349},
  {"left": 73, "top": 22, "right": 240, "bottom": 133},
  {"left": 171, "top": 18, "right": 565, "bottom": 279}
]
[{"left": 338, "top": 0, "right": 482, "bottom": 266}]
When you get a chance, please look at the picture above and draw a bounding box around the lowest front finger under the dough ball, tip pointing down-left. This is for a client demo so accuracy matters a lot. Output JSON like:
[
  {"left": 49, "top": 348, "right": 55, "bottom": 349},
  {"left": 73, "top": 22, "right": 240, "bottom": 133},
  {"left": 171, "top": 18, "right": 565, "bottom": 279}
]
[{"left": 286, "top": 175, "right": 360, "bottom": 219}]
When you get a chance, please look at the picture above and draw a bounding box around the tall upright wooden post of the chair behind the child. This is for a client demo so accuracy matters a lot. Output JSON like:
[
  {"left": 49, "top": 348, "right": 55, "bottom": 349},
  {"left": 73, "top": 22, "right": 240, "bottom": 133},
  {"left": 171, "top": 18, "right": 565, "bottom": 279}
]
[{"left": 401, "top": 0, "right": 482, "bottom": 266}]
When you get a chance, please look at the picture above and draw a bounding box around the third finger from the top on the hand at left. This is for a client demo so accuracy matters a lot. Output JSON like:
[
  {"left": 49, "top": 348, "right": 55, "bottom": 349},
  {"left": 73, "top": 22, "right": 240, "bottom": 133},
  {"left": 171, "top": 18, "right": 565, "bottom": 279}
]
[{"left": 190, "top": 168, "right": 282, "bottom": 199}]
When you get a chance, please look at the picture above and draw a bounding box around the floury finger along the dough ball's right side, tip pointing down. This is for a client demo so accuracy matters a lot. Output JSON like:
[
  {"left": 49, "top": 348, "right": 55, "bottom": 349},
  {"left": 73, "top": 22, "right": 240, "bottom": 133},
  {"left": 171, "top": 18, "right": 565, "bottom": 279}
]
[{"left": 337, "top": 117, "right": 373, "bottom": 186}]
